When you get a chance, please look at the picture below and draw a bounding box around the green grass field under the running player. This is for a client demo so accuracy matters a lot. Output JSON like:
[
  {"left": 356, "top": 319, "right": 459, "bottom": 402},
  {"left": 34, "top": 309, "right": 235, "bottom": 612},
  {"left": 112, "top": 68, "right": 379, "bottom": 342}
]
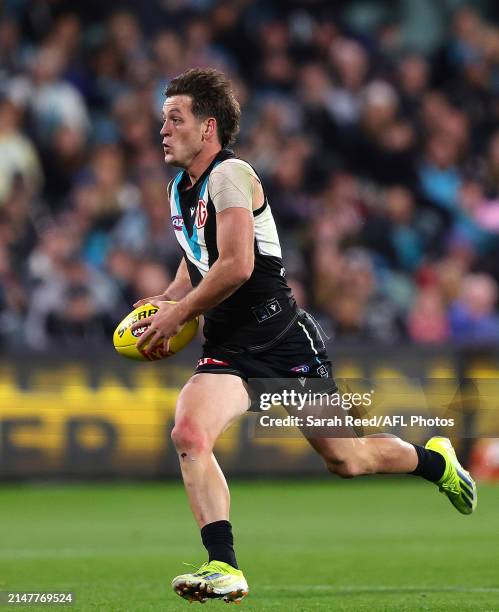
[{"left": 0, "top": 478, "right": 499, "bottom": 612}]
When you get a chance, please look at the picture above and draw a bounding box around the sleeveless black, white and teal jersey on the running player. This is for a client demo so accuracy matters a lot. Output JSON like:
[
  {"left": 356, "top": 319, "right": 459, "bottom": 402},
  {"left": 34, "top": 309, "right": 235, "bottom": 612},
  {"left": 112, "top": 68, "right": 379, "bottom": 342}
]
[{"left": 169, "top": 149, "right": 297, "bottom": 351}]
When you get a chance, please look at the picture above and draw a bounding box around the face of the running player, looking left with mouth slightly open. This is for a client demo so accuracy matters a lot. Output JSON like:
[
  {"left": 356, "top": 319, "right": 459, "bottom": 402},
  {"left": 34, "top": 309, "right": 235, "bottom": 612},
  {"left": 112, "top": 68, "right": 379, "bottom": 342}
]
[{"left": 160, "top": 96, "right": 206, "bottom": 168}]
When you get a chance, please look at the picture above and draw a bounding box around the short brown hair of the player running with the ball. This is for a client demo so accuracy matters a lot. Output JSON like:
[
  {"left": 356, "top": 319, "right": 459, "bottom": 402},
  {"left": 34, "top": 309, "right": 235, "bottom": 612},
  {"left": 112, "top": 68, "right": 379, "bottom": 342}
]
[{"left": 165, "top": 68, "right": 241, "bottom": 148}]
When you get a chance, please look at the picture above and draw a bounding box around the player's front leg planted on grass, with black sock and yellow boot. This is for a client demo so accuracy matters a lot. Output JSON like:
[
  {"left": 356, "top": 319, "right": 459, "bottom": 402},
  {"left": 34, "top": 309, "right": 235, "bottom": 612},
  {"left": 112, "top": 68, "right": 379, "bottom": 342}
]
[{"left": 172, "top": 374, "right": 249, "bottom": 602}]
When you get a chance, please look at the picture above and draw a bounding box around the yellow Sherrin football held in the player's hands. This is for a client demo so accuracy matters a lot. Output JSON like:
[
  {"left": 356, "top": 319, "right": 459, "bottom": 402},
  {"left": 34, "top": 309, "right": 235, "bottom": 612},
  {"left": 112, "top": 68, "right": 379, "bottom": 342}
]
[{"left": 113, "top": 302, "right": 199, "bottom": 361}]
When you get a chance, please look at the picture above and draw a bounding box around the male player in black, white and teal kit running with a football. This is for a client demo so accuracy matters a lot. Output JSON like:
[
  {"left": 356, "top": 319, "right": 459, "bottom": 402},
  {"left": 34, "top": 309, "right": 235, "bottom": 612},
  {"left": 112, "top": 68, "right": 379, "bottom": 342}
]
[{"left": 132, "top": 69, "right": 477, "bottom": 602}]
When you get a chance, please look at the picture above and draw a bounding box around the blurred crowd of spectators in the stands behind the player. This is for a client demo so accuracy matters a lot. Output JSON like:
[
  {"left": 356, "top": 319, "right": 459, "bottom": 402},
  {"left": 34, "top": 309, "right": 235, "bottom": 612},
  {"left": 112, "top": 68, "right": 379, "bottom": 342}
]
[{"left": 0, "top": 0, "right": 499, "bottom": 349}]
